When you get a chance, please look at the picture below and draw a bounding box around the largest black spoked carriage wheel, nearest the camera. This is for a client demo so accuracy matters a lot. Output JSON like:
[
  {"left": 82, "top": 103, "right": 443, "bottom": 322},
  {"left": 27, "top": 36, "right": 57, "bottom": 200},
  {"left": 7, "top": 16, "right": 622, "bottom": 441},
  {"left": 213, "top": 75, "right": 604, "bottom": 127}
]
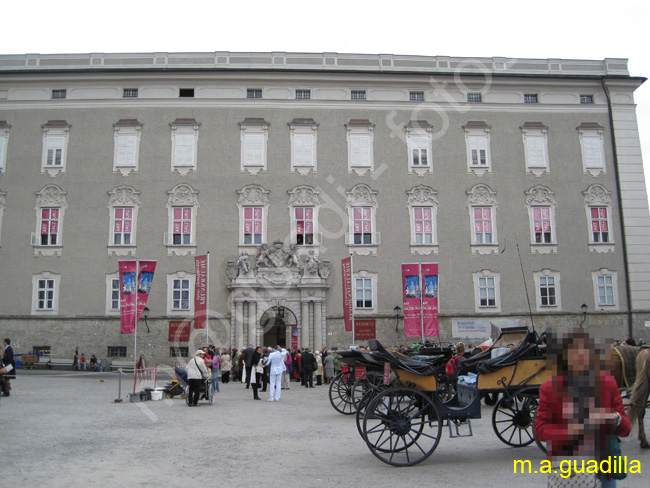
[{"left": 362, "top": 388, "right": 442, "bottom": 466}]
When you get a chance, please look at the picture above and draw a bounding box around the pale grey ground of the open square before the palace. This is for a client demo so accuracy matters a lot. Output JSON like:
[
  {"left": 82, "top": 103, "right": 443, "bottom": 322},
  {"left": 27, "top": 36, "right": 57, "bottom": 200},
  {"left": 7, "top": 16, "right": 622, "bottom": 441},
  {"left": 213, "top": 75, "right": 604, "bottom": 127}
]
[{"left": 0, "top": 371, "right": 650, "bottom": 488}]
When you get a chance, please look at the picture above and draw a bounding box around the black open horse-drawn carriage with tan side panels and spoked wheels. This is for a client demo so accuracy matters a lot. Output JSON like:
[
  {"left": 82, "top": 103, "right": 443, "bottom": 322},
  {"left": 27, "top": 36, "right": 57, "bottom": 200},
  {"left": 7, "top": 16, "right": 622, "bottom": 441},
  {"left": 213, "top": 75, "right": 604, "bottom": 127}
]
[{"left": 330, "top": 327, "right": 549, "bottom": 466}]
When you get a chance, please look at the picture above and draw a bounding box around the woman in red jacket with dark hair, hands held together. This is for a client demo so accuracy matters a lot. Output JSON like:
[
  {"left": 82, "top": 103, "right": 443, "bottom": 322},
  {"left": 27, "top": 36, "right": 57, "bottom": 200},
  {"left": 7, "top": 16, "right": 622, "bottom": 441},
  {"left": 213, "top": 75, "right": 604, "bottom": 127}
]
[{"left": 535, "top": 329, "right": 630, "bottom": 488}]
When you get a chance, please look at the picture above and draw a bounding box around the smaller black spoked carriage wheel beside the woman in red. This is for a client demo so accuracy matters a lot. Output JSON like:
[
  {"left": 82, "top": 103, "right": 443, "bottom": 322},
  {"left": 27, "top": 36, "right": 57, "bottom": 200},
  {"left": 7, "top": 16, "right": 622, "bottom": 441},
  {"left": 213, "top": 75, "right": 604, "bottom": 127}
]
[{"left": 492, "top": 389, "right": 539, "bottom": 447}]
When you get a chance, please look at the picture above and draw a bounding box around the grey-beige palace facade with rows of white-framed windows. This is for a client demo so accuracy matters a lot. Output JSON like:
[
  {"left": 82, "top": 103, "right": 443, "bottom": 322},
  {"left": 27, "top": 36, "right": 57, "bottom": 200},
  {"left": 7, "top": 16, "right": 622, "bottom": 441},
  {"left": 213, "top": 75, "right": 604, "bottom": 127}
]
[{"left": 0, "top": 52, "right": 650, "bottom": 363}]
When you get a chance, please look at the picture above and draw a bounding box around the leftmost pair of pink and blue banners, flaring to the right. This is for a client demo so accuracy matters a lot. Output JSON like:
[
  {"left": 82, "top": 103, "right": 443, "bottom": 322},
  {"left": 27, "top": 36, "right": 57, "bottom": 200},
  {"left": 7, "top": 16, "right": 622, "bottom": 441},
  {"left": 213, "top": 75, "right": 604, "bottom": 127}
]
[{"left": 118, "top": 261, "right": 156, "bottom": 334}]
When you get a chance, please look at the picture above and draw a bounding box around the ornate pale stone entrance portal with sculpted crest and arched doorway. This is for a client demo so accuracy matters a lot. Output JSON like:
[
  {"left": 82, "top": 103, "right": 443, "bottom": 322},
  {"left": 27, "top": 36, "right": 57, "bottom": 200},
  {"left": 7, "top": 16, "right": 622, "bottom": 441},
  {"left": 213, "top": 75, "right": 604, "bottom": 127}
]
[{"left": 226, "top": 240, "right": 331, "bottom": 350}]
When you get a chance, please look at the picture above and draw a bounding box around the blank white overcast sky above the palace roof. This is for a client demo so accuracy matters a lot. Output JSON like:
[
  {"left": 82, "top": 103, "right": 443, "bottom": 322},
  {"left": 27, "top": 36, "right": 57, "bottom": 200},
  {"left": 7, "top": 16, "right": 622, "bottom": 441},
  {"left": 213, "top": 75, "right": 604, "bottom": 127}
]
[{"left": 5, "top": 0, "right": 650, "bottom": 198}]
